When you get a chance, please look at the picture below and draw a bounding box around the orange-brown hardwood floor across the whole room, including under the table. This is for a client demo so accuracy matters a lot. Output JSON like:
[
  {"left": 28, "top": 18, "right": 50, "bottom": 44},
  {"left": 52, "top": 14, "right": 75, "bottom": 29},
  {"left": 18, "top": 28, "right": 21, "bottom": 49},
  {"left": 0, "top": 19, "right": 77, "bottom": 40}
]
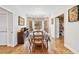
[{"left": 0, "top": 38, "right": 73, "bottom": 54}]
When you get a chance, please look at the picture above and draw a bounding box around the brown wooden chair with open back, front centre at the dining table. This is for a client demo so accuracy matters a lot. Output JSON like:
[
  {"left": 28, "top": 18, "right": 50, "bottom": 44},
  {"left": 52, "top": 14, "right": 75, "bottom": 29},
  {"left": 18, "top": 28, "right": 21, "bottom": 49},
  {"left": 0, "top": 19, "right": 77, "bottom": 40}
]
[{"left": 33, "top": 31, "right": 44, "bottom": 48}]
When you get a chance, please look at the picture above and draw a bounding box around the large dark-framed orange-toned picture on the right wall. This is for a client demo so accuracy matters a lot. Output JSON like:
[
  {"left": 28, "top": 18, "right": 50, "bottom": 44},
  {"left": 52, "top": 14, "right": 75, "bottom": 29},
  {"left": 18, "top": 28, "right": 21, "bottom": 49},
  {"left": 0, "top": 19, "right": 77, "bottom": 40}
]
[{"left": 68, "top": 5, "right": 79, "bottom": 22}]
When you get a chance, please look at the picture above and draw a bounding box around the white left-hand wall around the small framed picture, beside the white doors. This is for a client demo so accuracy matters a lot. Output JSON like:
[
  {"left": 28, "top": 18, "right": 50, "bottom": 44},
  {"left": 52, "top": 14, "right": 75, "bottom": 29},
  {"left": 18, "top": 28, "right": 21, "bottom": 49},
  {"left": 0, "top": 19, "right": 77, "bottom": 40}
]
[{"left": 1, "top": 5, "right": 26, "bottom": 47}]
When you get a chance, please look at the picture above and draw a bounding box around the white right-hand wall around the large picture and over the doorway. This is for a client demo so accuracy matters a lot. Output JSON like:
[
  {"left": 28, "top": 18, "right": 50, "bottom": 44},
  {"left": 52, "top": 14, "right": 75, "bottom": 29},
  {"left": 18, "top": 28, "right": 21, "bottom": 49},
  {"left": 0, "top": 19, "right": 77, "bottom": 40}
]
[{"left": 54, "top": 6, "right": 79, "bottom": 53}]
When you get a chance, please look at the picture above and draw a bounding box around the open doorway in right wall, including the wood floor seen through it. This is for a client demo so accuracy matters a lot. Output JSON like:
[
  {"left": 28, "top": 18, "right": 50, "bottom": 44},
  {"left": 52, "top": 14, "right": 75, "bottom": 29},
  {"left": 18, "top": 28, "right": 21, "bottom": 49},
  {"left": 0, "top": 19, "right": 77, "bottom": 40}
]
[{"left": 55, "top": 14, "right": 64, "bottom": 48}]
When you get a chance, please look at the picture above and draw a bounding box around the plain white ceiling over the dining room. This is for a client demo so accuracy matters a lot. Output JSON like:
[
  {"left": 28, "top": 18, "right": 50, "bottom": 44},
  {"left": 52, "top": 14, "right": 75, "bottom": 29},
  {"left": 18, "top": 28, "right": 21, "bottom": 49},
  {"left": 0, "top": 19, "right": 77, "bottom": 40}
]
[{"left": 2, "top": 5, "right": 73, "bottom": 16}]
